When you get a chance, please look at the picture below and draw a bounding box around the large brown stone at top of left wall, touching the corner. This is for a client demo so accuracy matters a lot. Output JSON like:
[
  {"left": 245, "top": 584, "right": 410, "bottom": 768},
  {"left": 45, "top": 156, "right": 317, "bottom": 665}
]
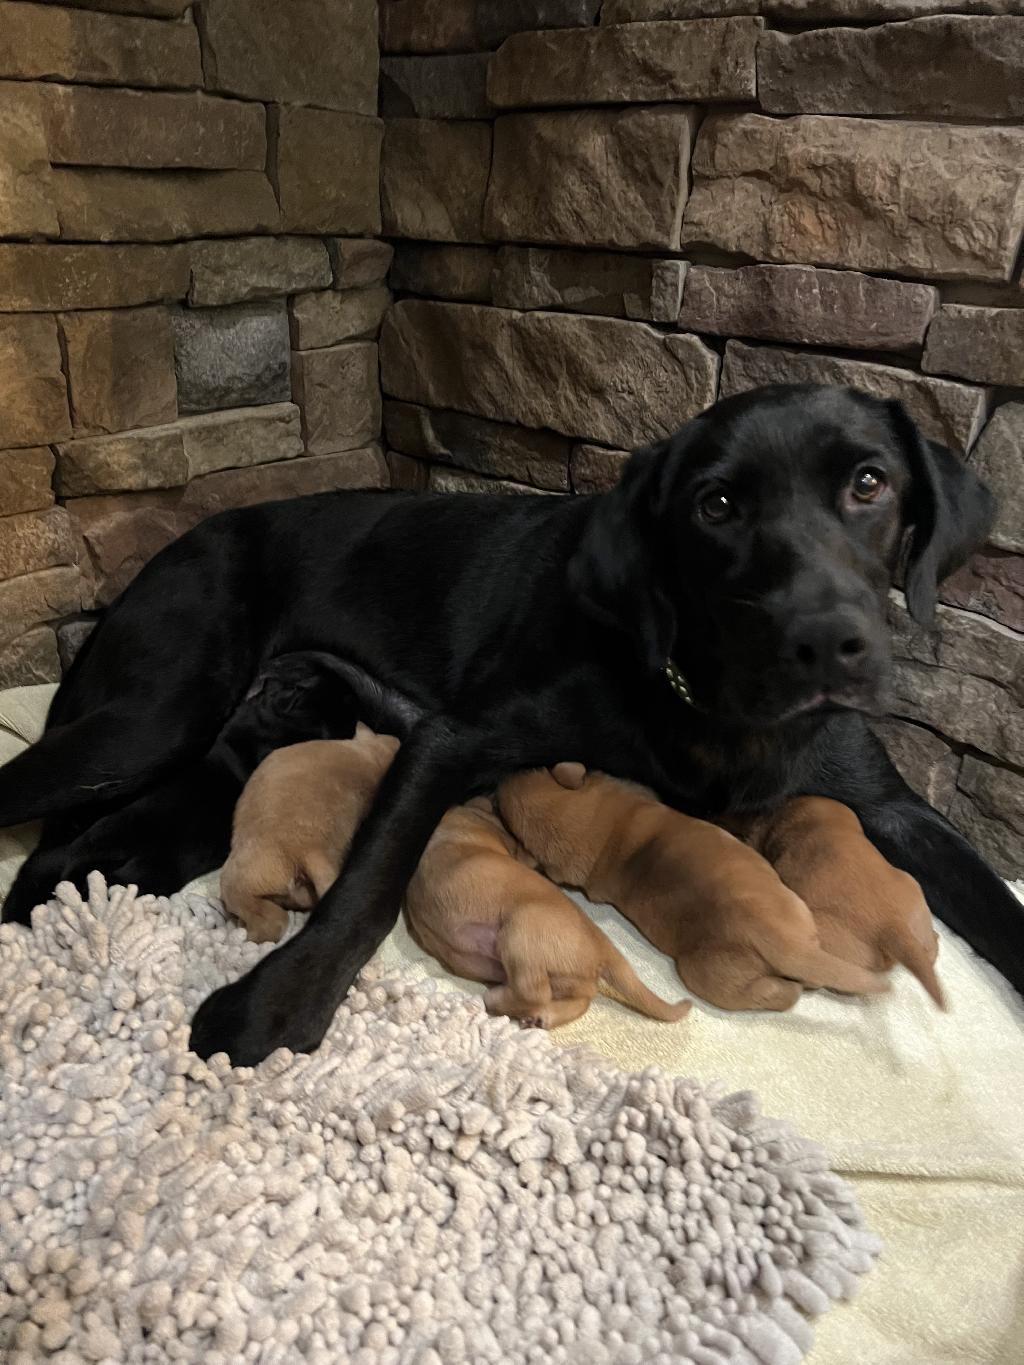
[{"left": 202, "top": 0, "right": 377, "bottom": 113}]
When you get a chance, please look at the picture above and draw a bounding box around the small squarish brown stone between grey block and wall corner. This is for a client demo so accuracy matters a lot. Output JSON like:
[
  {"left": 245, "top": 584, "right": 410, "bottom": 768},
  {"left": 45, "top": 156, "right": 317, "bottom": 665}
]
[{"left": 292, "top": 341, "right": 381, "bottom": 455}]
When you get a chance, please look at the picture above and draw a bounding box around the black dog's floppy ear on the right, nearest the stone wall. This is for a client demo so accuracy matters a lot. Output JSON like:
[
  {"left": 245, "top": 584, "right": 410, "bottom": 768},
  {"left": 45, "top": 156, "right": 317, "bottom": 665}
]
[{"left": 889, "top": 403, "right": 995, "bottom": 625}]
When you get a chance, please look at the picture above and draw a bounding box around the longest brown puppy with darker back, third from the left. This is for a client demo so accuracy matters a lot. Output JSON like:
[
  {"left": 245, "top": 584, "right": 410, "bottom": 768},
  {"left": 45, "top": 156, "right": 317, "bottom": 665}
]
[{"left": 498, "top": 763, "right": 886, "bottom": 1010}]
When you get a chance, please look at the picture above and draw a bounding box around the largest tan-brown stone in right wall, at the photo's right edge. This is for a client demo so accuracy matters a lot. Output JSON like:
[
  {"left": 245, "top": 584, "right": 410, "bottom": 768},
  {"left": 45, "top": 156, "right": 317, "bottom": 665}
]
[{"left": 683, "top": 113, "right": 1024, "bottom": 280}]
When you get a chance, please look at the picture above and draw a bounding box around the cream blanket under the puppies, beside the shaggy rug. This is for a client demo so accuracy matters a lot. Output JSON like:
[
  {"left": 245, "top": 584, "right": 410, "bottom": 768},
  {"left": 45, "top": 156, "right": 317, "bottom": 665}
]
[{"left": 0, "top": 688, "right": 1024, "bottom": 1365}]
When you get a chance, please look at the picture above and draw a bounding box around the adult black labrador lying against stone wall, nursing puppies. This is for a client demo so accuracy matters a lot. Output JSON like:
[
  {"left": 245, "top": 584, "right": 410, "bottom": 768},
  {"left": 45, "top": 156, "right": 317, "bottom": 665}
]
[{"left": 0, "top": 385, "right": 1024, "bottom": 1065}]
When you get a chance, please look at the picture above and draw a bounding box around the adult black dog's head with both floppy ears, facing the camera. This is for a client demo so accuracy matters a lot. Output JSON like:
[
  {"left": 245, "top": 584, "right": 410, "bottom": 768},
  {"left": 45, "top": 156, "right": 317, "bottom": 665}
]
[{"left": 569, "top": 385, "right": 993, "bottom": 725}]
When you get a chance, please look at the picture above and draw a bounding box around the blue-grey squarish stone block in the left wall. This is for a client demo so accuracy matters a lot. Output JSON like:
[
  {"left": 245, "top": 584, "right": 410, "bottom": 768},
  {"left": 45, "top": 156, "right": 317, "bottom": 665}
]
[{"left": 172, "top": 299, "right": 291, "bottom": 412}]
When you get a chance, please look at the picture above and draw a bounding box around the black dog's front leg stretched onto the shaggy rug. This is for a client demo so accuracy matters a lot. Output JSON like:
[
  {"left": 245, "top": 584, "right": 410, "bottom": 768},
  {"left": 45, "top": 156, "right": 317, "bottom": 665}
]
[{"left": 191, "top": 717, "right": 515, "bottom": 1066}]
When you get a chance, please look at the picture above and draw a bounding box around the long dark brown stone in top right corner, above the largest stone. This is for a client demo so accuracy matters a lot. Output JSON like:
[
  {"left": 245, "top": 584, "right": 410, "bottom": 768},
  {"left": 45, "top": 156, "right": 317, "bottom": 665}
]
[{"left": 758, "top": 15, "right": 1024, "bottom": 119}]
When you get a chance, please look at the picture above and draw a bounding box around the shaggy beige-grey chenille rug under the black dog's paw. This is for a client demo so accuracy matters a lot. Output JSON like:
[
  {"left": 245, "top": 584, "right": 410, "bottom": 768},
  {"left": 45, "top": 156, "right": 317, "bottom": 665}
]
[{"left": 0, "top": 876, "right": 878, "bottom": 1365}]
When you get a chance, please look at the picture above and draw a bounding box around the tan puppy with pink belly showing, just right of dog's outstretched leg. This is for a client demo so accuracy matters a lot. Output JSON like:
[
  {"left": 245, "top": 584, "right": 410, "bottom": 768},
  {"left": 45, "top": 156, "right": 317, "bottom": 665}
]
[{"left": 406, "top": 797, "right": 691, "bottom": 1028}]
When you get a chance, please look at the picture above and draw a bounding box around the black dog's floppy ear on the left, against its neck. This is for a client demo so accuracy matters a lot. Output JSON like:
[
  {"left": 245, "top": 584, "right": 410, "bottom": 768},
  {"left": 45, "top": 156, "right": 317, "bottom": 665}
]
[{"left": 569, "top": 441, "right": 676, "bottom": 672}]
